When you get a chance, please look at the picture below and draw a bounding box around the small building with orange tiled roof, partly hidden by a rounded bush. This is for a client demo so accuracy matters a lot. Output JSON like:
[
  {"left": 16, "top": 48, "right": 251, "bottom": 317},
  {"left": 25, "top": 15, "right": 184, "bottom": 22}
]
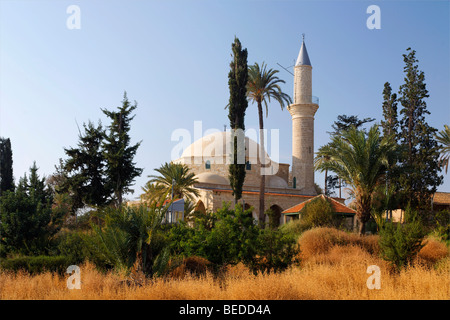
[{"left": 282, "top": 194, "right": 356, "bottom": 230}]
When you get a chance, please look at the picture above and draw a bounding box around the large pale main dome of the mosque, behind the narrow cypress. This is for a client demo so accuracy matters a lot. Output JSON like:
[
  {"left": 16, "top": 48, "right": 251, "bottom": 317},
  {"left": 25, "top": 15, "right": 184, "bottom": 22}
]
[{"left": 181, "top": 131, "right": 270, "bottom": 164}]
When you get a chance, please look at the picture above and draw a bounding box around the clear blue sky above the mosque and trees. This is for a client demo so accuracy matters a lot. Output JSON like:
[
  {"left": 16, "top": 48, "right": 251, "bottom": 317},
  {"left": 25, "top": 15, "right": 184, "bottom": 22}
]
[{"left": 0, "top": 0, "right": 450, "bottom": 198}]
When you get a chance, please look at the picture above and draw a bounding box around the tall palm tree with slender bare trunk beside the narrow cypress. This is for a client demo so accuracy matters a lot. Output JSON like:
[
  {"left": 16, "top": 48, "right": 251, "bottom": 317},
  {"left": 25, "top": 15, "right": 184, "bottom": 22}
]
[{"left": 247, "top": 62, "right": 292, "bottom": 227}]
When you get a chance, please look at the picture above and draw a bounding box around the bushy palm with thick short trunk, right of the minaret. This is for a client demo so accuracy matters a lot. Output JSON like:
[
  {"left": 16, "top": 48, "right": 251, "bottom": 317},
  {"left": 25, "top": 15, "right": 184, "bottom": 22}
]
[{"left": 318, "top": 125, "right": 396, "bottom": 235}]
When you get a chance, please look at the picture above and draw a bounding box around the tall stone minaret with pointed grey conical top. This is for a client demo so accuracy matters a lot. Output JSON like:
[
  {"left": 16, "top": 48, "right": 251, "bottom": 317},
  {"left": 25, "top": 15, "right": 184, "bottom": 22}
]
[{"left": 288, "top": 35, "right": 319, "bottom": 195}]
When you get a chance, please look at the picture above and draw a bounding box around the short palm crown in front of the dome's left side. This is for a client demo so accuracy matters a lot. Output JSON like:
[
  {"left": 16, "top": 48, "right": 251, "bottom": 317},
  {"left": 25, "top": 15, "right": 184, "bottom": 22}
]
[{"left": 142, "top": 162, "right": 199, "bottom": 201}]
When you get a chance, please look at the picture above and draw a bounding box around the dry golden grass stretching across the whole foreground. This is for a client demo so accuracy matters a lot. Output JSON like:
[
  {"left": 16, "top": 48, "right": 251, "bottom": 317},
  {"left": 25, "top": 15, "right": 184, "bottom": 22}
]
[{"left": 0, "top": 228, "right": 450, "bottom": 300}]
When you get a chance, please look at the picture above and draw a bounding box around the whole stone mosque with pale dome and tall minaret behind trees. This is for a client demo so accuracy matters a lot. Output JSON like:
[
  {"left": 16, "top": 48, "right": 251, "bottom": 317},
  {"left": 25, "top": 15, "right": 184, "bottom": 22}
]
[{"left": 174, "top": 40, "right": 355, "bottom": 225}]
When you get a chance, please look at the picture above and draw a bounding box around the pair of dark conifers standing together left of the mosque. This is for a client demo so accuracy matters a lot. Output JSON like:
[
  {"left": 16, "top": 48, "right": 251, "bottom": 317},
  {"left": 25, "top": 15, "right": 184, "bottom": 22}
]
[{"left": 59, "top": 93, "right": 142, "bottom": 212}]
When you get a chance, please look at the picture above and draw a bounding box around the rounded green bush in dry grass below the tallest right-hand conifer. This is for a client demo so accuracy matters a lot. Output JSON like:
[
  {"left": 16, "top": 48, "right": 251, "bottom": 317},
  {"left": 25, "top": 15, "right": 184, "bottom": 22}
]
[{"left": 379, "top": 209, "right": 426, "bottom": 271}]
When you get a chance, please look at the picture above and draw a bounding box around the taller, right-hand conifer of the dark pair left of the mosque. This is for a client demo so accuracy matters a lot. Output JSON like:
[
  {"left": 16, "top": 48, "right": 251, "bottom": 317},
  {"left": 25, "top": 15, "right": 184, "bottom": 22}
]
[{"left": 102, "top": 92, "right": 143, "bottom": 207}]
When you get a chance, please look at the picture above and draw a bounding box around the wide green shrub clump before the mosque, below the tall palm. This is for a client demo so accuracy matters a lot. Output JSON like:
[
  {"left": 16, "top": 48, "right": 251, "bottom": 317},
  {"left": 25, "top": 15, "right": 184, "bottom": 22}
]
[{"left": 170, "top": 203, "right": 298, "bottom": 273}]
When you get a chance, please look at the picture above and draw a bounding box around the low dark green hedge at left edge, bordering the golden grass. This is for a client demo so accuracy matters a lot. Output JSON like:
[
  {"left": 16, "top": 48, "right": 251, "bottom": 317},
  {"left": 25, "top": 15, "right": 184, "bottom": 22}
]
[{"left": 0, "top": 256, "right": 73, "bottom": 274}]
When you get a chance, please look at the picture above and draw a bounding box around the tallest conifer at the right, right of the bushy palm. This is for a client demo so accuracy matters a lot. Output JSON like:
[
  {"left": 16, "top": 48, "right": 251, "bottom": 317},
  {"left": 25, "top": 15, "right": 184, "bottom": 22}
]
[{"left": 399, "top": 48, "right": 443, "bottom": 208}]
